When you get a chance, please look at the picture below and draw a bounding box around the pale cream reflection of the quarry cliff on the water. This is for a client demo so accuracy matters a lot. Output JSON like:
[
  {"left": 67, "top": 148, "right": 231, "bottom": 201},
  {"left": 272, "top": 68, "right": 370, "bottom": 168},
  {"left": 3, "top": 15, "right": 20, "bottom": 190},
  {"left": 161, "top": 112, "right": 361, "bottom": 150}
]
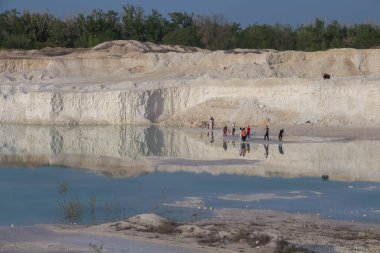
[{"left": 0, "top": 125, "right": 380, "bottom": 182}]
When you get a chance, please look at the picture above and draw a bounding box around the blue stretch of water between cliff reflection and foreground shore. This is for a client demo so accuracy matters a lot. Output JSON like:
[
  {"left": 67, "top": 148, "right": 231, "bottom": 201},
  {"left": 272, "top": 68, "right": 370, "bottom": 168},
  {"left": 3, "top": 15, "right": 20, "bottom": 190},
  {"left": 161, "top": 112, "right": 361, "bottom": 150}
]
[{"left": 0, "top": 167, "right": 380, "bottom": 225}]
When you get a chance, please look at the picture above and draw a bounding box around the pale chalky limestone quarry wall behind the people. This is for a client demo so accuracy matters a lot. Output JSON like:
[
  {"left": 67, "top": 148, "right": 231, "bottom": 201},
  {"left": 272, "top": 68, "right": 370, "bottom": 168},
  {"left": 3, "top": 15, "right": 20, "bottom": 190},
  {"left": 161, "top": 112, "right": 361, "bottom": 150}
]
[{"left": 0, "top": 41, "right": 380, "bottom": 127}]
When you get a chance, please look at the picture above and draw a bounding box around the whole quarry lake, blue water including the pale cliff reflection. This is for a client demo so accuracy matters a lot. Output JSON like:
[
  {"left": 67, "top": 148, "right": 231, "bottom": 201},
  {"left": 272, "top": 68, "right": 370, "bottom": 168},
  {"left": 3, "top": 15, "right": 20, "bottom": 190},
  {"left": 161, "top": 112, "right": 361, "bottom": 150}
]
[{"left": 0, "top": 125, "right": 380, "bottom": 226}]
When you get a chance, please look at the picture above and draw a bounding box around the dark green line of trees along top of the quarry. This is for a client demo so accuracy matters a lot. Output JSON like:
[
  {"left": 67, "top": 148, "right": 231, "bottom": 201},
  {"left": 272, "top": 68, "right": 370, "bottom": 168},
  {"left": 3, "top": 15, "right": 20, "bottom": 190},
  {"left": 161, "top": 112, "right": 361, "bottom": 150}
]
[{"left": 0, "top": 4, "right": 380, "bottom": 51}]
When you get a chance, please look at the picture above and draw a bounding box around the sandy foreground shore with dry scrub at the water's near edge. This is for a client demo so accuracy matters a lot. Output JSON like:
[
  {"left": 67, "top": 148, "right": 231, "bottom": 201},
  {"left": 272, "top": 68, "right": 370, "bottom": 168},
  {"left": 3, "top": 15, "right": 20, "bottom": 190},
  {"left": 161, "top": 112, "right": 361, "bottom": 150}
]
[{"left": 0, "top": 209, "right": 380, "bottom": 253}]
